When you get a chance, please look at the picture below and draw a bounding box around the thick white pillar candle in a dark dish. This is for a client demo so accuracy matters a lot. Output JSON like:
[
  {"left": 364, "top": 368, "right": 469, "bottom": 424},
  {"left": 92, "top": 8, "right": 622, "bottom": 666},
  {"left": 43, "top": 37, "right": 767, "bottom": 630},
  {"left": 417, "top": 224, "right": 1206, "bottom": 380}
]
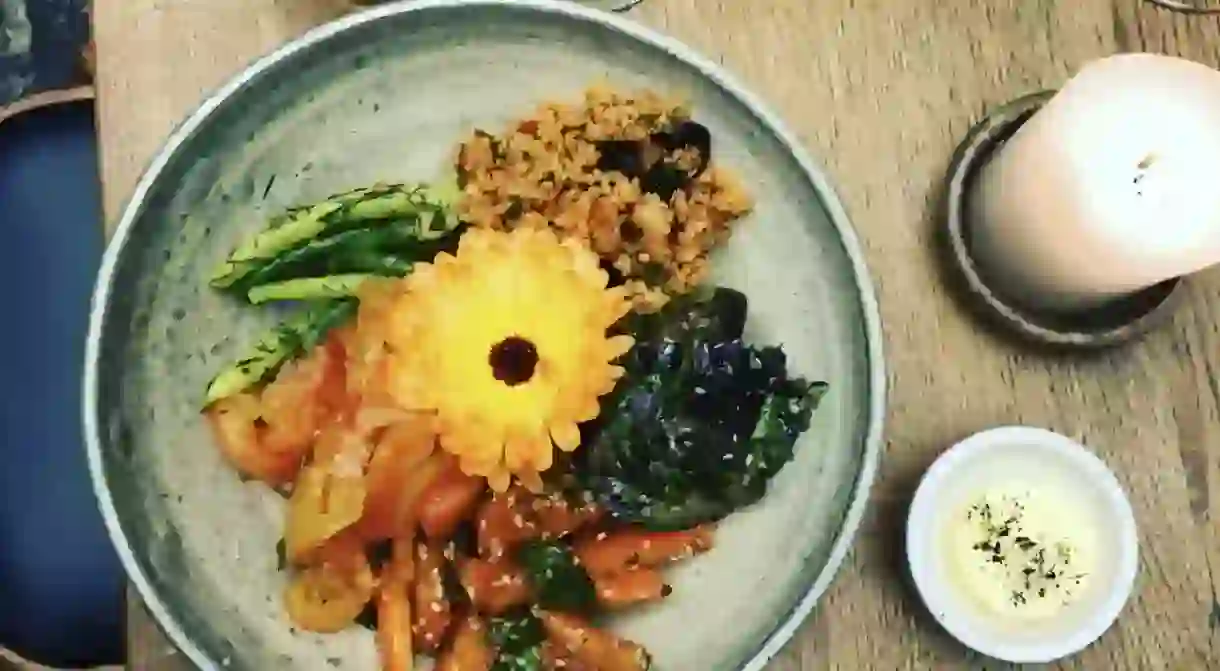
[{"left": 969, "top": 54, "right": 1220, "bottom": 311}]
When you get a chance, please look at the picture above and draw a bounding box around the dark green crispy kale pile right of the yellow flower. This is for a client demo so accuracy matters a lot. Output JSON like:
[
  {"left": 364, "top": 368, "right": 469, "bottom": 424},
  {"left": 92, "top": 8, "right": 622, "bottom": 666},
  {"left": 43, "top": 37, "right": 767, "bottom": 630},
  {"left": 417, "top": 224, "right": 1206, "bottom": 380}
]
[{"left": 573, "top": 289, "right": 827, "bottom": 529}]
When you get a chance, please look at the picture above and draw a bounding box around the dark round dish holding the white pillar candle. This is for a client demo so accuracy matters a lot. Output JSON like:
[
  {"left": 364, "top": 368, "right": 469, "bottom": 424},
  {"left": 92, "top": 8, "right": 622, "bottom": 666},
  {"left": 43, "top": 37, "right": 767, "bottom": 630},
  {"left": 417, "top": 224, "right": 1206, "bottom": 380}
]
[{"left": 939, "top": 92, "right": 1182, "bottom": 349}]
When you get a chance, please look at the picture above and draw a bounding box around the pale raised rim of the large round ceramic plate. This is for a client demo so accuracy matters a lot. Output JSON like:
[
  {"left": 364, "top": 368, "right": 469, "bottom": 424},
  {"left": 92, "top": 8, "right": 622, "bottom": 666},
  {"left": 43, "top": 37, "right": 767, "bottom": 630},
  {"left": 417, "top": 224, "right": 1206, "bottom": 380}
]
[{"left": 82, "top": 0, "right": 887, "bottom": 671}]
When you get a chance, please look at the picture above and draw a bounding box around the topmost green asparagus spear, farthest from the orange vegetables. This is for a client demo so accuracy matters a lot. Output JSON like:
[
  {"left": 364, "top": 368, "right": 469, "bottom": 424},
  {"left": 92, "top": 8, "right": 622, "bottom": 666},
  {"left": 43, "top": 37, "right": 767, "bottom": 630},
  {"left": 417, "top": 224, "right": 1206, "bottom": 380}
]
[{"left": 211, "top": 184, "right": 456, "bottom": 289}]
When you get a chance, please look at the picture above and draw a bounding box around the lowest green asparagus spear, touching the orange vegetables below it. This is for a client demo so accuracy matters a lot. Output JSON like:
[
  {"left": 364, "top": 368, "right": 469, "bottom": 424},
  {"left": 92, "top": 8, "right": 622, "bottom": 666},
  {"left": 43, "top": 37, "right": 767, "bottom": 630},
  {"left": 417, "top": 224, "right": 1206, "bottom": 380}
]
[{"left": 204, "top": 299, "right": 357, "bottom": 405}]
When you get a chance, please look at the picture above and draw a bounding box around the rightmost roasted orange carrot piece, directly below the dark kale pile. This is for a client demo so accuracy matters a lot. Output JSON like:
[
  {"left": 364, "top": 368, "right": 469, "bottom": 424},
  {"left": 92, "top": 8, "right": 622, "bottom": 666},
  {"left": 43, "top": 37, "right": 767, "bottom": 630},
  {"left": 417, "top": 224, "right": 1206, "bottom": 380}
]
[{"left": 576, "top": 527, "right": 714, "bottom": 576}]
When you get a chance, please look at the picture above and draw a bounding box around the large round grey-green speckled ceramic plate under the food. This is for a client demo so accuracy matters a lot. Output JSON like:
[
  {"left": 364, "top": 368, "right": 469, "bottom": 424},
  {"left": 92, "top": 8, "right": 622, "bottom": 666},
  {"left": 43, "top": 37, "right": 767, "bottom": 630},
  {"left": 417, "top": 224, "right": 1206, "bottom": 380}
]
[{"left": 84, "top": 0, "right": 885, "bottom": 671}]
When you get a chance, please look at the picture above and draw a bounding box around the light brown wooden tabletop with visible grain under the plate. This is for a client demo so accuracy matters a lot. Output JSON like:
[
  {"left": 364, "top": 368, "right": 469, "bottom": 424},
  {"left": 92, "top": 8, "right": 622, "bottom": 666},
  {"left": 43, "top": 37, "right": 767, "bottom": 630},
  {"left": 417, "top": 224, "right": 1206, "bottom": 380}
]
[{"left": 94, "top": 0, "right": 1220, "bottom": 671}]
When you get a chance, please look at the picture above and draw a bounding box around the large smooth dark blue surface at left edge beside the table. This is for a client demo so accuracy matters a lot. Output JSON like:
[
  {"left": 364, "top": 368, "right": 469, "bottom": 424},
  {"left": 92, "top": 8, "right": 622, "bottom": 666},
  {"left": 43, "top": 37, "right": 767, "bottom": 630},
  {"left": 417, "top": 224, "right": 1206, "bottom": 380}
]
[{"left": 0, "top": 98, "right": 124, "bottom": 666}]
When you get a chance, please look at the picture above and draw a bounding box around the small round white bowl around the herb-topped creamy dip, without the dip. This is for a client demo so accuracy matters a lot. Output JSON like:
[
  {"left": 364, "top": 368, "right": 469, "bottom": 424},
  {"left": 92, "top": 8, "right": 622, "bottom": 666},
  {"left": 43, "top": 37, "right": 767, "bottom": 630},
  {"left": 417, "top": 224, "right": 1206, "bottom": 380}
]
[{"left": 906, "top": 427, "right": 1138, "bottom": 664}]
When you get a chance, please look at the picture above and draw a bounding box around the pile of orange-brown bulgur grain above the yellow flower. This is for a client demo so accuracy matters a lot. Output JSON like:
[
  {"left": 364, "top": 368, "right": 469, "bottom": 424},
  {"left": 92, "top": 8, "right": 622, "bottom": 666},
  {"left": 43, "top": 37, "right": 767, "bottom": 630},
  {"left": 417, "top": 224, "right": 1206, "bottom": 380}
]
[{"left": 456, "top": 88, "right": 753, "bottom": 311}]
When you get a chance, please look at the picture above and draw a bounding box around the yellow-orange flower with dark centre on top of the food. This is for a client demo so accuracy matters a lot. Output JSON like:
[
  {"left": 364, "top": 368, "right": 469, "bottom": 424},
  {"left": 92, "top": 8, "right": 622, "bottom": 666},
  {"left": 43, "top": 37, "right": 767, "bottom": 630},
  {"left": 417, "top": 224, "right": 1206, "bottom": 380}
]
[{"left": 386, "top": 228, "right": 632, "bottom": 490}]
